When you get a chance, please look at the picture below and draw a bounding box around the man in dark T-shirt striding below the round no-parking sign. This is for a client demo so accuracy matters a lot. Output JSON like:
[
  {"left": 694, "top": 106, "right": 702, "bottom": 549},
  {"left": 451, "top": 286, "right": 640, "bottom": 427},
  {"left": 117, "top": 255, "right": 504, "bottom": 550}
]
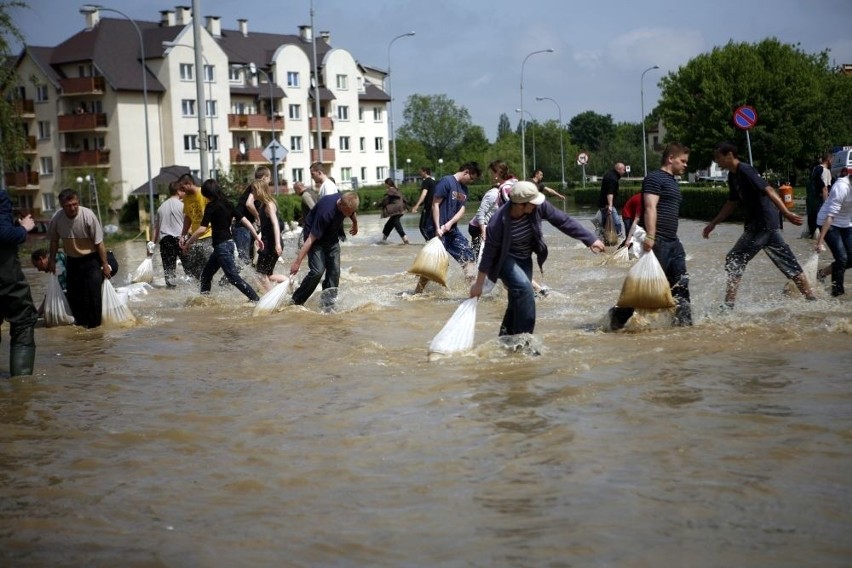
[{"left": 703, "top": 142, "right": 816, "bottom": 309}]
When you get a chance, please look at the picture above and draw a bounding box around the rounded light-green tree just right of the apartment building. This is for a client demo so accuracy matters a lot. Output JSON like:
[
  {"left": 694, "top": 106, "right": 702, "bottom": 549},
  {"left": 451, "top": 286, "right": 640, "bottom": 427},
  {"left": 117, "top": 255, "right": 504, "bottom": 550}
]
[{"left": 399, "top": 95, "right": 471, "bottom": 162}]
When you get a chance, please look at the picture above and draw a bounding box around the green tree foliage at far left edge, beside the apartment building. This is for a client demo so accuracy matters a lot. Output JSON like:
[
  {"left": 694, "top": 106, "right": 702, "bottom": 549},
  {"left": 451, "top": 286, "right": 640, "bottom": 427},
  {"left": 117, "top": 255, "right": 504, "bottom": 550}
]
[{"left": 0, "top": 0, "right": 27, "bottom": 169}]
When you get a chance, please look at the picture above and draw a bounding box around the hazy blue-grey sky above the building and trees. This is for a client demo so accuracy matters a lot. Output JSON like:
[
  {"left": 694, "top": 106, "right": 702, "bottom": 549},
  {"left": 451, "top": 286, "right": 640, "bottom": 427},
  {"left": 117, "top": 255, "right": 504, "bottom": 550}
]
[{"left": 12, "top": 0, "right": 852, "bottom": 140}]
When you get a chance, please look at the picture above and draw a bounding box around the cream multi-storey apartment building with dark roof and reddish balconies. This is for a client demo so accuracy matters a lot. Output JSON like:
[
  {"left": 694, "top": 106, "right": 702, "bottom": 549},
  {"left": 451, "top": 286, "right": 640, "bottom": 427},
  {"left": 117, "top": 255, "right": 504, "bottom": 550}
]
[{"left": 4, "top": 6, "right": 390, "bottom": 222}]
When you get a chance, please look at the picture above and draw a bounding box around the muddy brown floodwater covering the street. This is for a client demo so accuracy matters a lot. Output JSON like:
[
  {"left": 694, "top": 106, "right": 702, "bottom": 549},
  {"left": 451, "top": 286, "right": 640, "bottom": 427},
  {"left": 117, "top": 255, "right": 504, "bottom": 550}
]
[{"left": 0, "top": 205, "right": 852, "bottom": 568}]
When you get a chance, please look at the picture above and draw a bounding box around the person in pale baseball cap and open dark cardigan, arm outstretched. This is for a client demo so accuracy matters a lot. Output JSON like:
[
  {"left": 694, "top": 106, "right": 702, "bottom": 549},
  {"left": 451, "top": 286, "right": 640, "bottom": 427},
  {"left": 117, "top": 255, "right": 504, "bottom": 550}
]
[{"left": 470, "top": 181, "right": 605, "bottom": 335}]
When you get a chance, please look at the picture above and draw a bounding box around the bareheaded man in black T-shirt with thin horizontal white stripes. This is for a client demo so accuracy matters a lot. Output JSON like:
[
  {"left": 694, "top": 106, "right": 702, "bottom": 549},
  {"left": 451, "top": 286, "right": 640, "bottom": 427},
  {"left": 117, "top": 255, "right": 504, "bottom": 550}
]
[{"left": 608, "top": 143, "right": 692, "bottom": 331}]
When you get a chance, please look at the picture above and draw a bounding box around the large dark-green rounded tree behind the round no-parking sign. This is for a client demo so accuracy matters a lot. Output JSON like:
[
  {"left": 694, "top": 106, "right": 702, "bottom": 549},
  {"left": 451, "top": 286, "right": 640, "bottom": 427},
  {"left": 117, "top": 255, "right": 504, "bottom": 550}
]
[{"left": 658, "top": 38, "right": 850, "bottom": 173}]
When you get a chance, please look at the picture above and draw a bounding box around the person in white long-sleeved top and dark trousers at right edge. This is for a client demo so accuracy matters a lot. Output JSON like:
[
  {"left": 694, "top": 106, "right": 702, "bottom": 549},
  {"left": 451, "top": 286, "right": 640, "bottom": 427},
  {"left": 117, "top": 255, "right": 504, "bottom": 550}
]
[{"left": 814, "top": 168, "right": 852, "bottom": 296}]
